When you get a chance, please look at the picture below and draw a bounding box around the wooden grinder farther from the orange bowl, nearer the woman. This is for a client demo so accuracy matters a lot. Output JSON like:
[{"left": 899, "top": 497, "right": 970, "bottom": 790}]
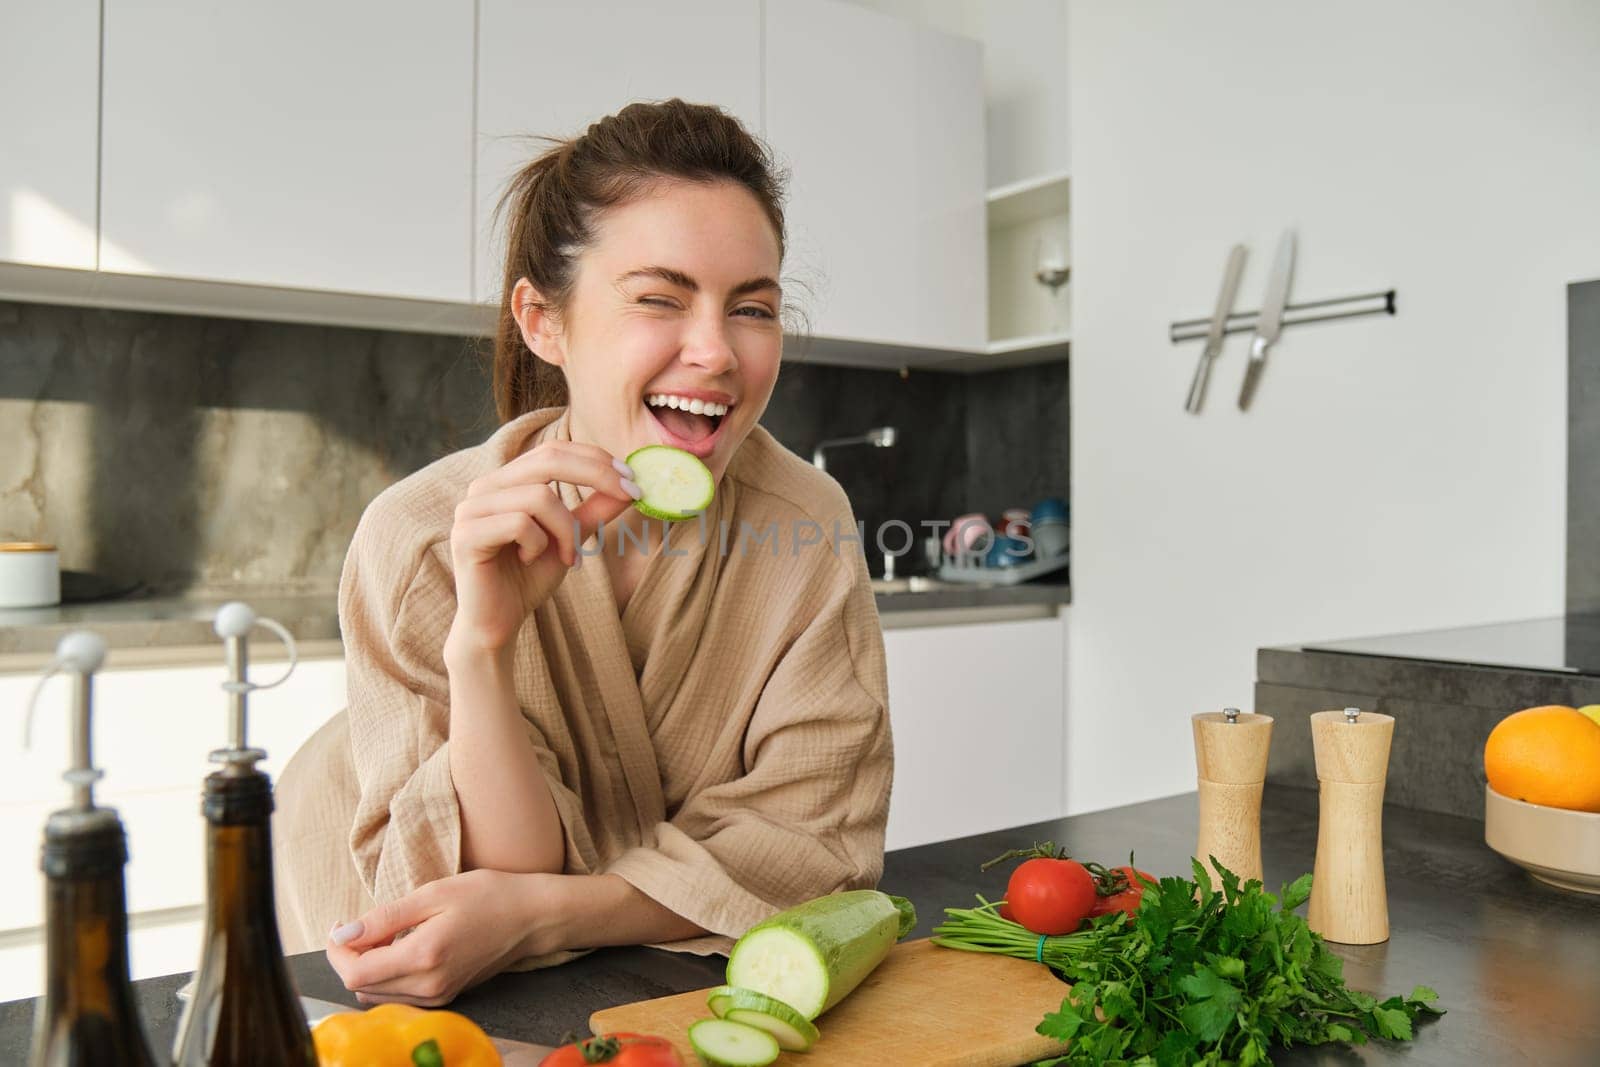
[{"left": 1194, "top": 707, "right": 1272, "bottom": 883}]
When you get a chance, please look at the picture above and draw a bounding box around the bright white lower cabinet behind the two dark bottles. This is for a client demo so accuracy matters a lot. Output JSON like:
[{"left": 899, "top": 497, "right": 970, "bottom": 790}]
[{"left": 0, "top": 659, "right": 346, "bottom": 1000}]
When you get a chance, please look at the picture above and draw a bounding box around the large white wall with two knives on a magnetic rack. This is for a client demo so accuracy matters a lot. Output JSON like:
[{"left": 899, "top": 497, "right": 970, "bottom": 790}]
[{"left": 1067, "top": 0, "right": 1600, "bottom": 811}]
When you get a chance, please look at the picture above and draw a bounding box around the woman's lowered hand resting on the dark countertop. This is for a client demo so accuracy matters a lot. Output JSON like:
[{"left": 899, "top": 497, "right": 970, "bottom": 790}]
[{"left": 328, "top": 870, "right": 560, "bottom": 1008}]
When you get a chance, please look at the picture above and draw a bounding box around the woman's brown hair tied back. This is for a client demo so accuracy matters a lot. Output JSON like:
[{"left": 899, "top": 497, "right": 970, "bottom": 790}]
[{"left": 493, "top": 98, "right": 786, "bottom": 422}]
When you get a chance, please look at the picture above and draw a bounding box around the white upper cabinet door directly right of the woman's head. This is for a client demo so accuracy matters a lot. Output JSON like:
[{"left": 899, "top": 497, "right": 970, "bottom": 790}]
[{"left": 765, "top": 0, "right": 987, "bottom": 350}]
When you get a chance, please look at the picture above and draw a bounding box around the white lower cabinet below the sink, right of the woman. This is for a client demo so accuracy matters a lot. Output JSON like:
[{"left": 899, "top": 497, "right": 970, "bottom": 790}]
[{"left": 883, "top": 616, "right": 1066, "bottom": 848}]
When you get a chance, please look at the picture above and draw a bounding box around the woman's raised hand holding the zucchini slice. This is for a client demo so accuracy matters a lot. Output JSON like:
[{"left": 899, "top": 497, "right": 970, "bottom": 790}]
[{"left": 446, "top": 442, "right": 640, "bottom": 654}]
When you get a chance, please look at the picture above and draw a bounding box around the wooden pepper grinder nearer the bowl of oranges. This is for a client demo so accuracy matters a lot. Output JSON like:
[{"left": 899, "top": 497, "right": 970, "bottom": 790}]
[{"left": 1306, "top": 707, "right": 1395, "bottom": 945}]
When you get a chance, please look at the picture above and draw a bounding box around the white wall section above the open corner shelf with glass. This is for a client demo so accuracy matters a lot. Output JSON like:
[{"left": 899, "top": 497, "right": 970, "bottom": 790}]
[{"left": 854, "top": 0, "right": 1070, "bottom": 189}]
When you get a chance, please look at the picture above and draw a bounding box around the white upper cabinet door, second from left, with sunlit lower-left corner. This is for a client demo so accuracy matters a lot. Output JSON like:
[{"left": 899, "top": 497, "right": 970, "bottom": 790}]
[{"left": 101, "top": 0, "right": 474, "bottom": 301}]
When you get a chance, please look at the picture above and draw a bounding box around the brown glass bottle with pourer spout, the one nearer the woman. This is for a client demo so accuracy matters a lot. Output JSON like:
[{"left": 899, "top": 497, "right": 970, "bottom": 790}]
[{"left": 176, "top": 603, "right": 317, "bottom": 1067}]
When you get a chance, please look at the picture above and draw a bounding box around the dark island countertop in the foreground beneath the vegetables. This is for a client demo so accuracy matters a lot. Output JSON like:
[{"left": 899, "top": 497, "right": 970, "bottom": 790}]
[{"left": 0, "top": 785, "right": 1600, "bottom": 1067}]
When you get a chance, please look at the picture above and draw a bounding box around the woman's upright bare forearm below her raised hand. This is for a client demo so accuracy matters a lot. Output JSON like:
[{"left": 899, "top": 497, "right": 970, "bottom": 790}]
[{"left": 445, "top": 649, "right": 566, "bottom": 873}]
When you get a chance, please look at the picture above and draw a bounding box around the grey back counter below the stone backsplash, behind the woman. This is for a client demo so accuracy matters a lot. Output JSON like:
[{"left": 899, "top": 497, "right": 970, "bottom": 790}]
[{"left": 0, "top": 582, "right": 1072, "bottom": 672}]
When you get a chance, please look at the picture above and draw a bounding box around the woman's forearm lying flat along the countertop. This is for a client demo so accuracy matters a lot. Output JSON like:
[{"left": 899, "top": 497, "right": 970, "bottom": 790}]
[{"left": 526, "top": 875, "right": 706, "bottom": 955}]
